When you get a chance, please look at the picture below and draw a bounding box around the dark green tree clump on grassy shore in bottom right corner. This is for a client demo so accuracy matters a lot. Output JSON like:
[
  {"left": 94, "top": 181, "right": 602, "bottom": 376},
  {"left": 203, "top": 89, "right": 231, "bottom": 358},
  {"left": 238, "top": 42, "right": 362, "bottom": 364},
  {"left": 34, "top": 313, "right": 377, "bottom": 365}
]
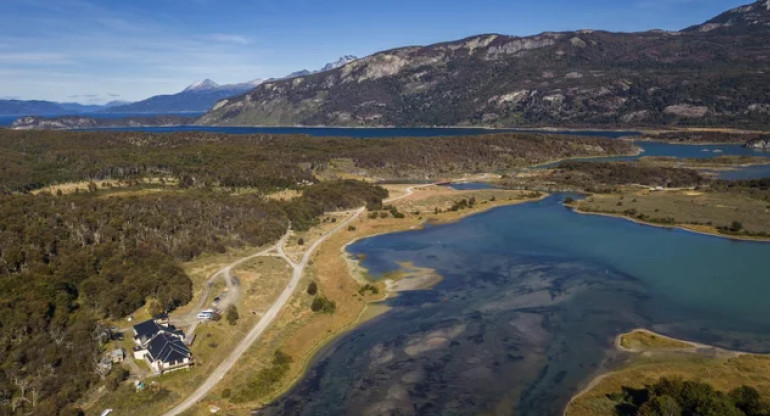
[{"left": 609, "top": 378, "right": 770, "bottom": 416}]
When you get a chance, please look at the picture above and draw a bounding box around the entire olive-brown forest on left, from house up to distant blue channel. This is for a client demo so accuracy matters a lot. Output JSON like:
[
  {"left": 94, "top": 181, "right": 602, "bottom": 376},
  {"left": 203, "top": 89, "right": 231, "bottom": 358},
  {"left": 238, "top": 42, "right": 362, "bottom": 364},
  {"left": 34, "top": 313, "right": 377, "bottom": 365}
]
[{"left": 0, "top": 130, "right": 634, "bottom": 415}]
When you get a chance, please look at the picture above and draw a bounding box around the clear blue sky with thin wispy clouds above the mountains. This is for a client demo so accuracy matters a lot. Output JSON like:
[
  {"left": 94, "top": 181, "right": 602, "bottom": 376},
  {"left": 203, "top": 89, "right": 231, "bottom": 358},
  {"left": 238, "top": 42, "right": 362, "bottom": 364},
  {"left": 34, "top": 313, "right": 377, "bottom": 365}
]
[{"left": 0, "top": 0, "right": 750, "bottom": 103}]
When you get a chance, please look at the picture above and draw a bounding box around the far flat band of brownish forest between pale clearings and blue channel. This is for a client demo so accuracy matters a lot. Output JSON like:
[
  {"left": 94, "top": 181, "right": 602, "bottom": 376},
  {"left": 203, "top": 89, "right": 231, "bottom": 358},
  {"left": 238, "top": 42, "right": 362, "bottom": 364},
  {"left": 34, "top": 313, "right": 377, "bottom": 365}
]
[{"left": 0, "top": 130, "right": 635, "bottom": 192}]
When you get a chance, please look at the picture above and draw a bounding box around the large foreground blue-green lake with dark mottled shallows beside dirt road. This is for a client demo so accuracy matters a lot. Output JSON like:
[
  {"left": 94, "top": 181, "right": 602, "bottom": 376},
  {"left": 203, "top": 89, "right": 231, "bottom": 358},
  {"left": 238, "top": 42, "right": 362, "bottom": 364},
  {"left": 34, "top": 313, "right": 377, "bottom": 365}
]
[{"left": 260, "top": 195, "right": 770, "bottom": 416}]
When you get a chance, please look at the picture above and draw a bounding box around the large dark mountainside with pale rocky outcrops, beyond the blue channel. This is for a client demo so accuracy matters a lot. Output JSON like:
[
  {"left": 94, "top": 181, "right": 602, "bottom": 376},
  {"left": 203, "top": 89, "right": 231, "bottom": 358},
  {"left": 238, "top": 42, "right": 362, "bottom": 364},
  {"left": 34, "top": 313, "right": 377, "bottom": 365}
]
[{"left": 199, "top": 0, "right": 770, "bottom": 128}]
